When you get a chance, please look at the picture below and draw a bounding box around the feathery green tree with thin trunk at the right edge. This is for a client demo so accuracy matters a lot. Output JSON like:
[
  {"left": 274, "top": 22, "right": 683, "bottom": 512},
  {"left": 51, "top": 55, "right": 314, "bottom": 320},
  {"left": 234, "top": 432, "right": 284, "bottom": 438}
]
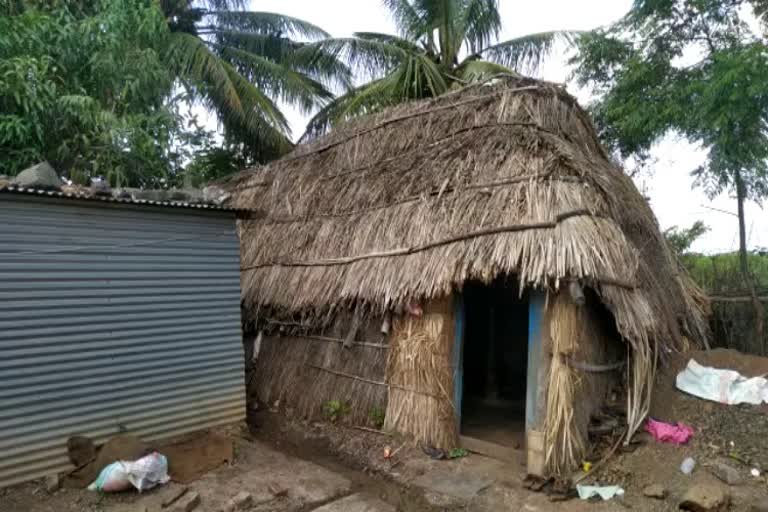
[{"left": 575, "top": 0, "right": 768, "bottom": 340}]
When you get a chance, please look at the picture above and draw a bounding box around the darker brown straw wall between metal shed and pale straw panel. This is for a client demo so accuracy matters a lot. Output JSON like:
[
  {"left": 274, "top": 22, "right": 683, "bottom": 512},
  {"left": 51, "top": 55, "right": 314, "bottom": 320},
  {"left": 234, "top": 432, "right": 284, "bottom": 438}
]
[{"left": 248, "top": 319, "right": 387, "bottom": 425}]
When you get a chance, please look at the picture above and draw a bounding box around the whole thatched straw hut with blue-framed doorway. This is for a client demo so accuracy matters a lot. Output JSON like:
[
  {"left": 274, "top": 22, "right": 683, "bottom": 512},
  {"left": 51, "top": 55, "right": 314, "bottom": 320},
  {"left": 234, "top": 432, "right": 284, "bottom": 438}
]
[{"left": 230, "top": 77, "right": 707, "bottom": 473}]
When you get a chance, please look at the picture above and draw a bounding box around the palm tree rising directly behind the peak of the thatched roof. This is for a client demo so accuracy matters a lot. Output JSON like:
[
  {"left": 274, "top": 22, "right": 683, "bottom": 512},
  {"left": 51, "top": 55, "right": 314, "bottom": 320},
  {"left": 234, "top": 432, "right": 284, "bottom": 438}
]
[{"left": 304, "top": 0, "right": 573, "bottom": 138}]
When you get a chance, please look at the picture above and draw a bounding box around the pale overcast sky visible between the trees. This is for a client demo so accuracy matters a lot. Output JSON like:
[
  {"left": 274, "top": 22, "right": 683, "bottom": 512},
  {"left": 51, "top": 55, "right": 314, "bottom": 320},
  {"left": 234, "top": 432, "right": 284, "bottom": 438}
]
[{"left": 243, "top": 0, "right": 768, "bottom": 253}]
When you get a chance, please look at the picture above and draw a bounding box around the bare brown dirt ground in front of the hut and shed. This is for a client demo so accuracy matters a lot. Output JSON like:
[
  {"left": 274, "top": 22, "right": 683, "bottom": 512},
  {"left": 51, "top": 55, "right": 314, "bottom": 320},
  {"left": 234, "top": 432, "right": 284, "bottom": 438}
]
[{"left": 0, "top": 350, "right": 768, "bottom": 512}]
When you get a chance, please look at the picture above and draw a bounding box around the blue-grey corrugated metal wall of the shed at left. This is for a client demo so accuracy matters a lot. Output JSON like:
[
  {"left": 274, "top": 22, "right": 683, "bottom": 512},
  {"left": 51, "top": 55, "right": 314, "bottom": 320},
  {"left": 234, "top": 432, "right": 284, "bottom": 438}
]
[{"left": 0, "top": 194, "right": 245, "bottom": 486}]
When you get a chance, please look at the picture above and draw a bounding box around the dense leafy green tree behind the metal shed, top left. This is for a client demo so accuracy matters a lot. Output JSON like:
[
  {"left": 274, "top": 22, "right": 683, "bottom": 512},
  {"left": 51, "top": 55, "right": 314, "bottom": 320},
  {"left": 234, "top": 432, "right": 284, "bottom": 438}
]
[{"left": 0, "top": 0, "right": 177, "bottom": 185}]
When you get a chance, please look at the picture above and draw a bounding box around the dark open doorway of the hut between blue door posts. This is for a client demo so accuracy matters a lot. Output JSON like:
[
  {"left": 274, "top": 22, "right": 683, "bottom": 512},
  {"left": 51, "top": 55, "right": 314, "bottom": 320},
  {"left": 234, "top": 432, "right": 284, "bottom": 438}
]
[{"left": 461, "top": 278, "right": 528, "bottom": 448}]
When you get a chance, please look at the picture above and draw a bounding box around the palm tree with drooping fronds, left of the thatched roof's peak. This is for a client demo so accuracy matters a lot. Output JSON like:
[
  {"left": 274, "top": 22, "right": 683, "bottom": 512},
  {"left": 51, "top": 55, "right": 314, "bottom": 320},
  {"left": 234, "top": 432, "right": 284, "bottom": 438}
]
[{"left": 160, "top": 0, "right": 351, "bottom": 161}]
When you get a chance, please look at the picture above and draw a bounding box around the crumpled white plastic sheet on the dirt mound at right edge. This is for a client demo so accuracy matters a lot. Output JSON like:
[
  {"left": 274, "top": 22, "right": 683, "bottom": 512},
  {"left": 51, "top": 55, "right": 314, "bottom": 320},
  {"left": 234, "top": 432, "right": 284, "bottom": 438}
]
[{"left": 675, "top": 359, "right": 768, "bottom": 405}]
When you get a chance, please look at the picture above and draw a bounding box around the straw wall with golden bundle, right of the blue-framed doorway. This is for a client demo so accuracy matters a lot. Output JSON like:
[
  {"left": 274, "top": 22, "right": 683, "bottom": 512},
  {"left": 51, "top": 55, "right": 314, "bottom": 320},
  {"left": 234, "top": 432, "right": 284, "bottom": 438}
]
[{"left": 545, "top": 292, "right": 624, "bottom": 475}]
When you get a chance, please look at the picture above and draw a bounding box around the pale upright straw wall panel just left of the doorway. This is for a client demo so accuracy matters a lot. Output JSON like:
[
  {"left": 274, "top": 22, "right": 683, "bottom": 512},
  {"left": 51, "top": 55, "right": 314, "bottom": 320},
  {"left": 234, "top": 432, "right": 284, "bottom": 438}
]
[{"left": 384, "top": 296, "right": 458, "bottom": 449}]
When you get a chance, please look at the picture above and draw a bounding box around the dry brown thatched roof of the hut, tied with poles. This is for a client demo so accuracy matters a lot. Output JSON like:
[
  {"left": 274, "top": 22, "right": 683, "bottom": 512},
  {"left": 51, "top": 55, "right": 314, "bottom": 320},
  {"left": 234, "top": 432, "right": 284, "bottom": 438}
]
[{"left": 230, "top": 78, "right": 706, "bottom": 349}]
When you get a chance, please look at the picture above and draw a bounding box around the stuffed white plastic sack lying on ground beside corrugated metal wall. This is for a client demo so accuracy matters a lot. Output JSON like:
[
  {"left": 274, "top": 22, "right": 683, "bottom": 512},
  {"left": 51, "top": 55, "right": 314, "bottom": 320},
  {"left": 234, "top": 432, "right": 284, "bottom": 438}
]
[{"left": 88, "top": 452, "right": 170, "bottom": 492}]
